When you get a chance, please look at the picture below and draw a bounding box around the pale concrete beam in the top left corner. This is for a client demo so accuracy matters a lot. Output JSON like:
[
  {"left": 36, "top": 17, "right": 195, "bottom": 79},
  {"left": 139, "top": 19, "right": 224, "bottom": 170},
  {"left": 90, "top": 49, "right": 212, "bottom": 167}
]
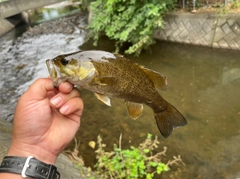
[{"left": 0, "top": 0, "right": 64, "bottom": 18}]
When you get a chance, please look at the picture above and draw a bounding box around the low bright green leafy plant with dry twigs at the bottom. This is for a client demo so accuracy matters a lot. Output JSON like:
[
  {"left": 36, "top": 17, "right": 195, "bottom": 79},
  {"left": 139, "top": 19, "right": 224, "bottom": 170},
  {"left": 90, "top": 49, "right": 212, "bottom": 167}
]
[{"left": 95, "top": 134, "right": 184, "bottom": 179}]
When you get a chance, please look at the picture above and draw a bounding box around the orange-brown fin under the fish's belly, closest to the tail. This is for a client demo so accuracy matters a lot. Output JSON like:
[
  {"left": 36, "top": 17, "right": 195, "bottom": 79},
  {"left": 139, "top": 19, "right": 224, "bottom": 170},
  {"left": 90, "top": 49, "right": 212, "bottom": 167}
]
[{"left": 126, "top": 101, "right": 143, "bottom": 119}]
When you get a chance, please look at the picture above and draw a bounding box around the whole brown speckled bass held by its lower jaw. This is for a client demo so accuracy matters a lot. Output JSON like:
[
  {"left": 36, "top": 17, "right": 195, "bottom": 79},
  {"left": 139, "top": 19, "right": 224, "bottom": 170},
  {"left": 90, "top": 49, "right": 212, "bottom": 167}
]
[{"left": 46, "top": 50, "right": 187, "bottom": 138}]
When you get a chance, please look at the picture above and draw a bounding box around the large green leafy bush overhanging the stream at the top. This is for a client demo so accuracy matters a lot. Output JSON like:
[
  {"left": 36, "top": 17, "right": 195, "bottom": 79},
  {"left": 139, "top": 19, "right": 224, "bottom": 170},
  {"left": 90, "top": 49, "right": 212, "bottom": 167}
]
[{"left": 88, "top": 0, "right": 176, "bottom": 55}]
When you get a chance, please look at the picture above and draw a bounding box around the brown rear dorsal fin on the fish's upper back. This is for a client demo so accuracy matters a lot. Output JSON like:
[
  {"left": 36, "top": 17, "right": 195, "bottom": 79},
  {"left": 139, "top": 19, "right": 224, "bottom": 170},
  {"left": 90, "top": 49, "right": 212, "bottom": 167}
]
[{"left": 141, "top": 67, "right": 167, "bottom": 91}]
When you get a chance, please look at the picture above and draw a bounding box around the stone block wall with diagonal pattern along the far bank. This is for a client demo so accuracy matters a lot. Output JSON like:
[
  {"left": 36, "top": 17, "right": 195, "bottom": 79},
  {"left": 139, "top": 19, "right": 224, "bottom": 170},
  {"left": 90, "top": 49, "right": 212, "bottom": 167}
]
[{"left": 154, "top": 13, "right": 240, "bottom": 50}]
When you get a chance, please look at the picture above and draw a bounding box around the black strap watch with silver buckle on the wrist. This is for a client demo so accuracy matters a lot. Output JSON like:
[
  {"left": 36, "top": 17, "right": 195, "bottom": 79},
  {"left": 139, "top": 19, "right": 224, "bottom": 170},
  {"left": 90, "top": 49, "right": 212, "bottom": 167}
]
[{"left": 0, "top": 156, "right": 60, "bottom": 179}]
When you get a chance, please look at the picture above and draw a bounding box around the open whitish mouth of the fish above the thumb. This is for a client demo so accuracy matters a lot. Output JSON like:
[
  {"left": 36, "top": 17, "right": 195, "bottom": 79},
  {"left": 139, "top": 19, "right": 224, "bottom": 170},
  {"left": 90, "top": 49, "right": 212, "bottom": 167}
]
[{"left": 46, "top": 60, "right": 66, "bottom": 87}]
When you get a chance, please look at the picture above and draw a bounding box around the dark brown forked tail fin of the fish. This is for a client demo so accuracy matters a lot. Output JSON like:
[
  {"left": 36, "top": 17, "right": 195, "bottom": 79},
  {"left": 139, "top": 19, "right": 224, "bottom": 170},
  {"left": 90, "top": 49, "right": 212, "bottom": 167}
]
[{"left": 155, "top": 103, "right": 187, "bottom": 138}]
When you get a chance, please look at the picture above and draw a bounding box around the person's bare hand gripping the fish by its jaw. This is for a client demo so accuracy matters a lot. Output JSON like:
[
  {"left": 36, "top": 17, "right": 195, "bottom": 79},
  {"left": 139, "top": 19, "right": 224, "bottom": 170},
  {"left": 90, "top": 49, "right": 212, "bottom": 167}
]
[{"left": 8, "top": 78, "right": 83, "bottom": 164}]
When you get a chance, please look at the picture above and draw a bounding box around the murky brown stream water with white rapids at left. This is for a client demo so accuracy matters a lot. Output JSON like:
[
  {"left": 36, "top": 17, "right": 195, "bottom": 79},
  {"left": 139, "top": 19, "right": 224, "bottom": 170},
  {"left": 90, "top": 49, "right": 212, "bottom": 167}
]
[{"left": 0, "top": 16, "right": 240, "bottom": 179}]
